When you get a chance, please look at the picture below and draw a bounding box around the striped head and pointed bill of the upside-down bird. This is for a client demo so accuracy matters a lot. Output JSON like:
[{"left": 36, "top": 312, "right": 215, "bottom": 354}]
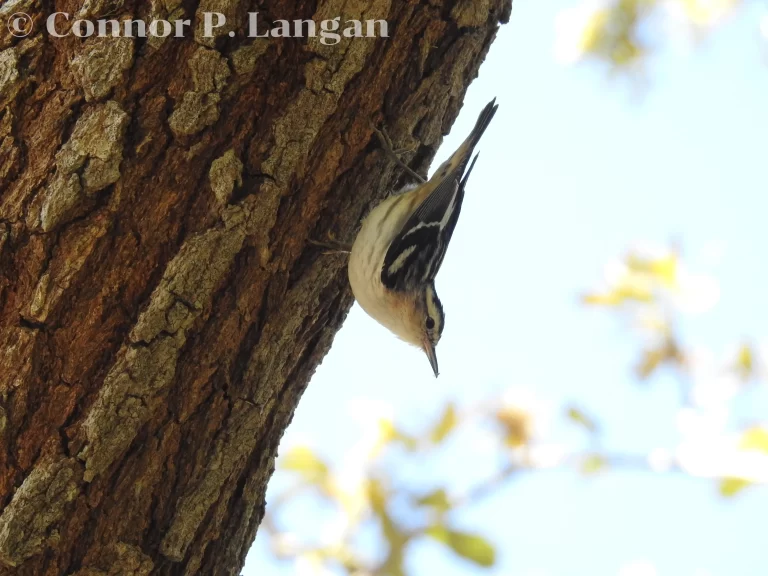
[{"left": 400, "top": 284, "right": 445, "bottom": 378}]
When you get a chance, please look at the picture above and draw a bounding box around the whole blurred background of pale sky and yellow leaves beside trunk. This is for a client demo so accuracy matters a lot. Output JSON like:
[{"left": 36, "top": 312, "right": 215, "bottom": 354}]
[{"left": 243, "top": 0, "right": 768, "bottom": 576}]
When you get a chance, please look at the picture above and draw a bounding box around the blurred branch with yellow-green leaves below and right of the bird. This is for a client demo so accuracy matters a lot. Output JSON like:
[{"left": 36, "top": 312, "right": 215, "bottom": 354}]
[{"left": 262, "top": 247, "right": 768, "bottom": 576}]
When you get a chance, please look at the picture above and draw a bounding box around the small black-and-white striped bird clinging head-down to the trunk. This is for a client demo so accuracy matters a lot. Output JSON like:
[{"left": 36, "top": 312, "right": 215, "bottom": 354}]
[{"left": 347, "top": 98, "right": 498, "bottom": 377}]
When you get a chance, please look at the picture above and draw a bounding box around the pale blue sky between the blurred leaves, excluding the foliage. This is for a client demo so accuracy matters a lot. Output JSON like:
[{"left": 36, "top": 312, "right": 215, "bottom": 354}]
[{"left": 243, "top": 1, "right": 768, "bottom": 576}]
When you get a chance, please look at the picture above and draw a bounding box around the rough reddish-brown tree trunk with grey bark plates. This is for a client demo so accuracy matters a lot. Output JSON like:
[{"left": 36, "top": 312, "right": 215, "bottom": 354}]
[{"left": 0, "top": 0, "right": 511, "bottom": 576}]
